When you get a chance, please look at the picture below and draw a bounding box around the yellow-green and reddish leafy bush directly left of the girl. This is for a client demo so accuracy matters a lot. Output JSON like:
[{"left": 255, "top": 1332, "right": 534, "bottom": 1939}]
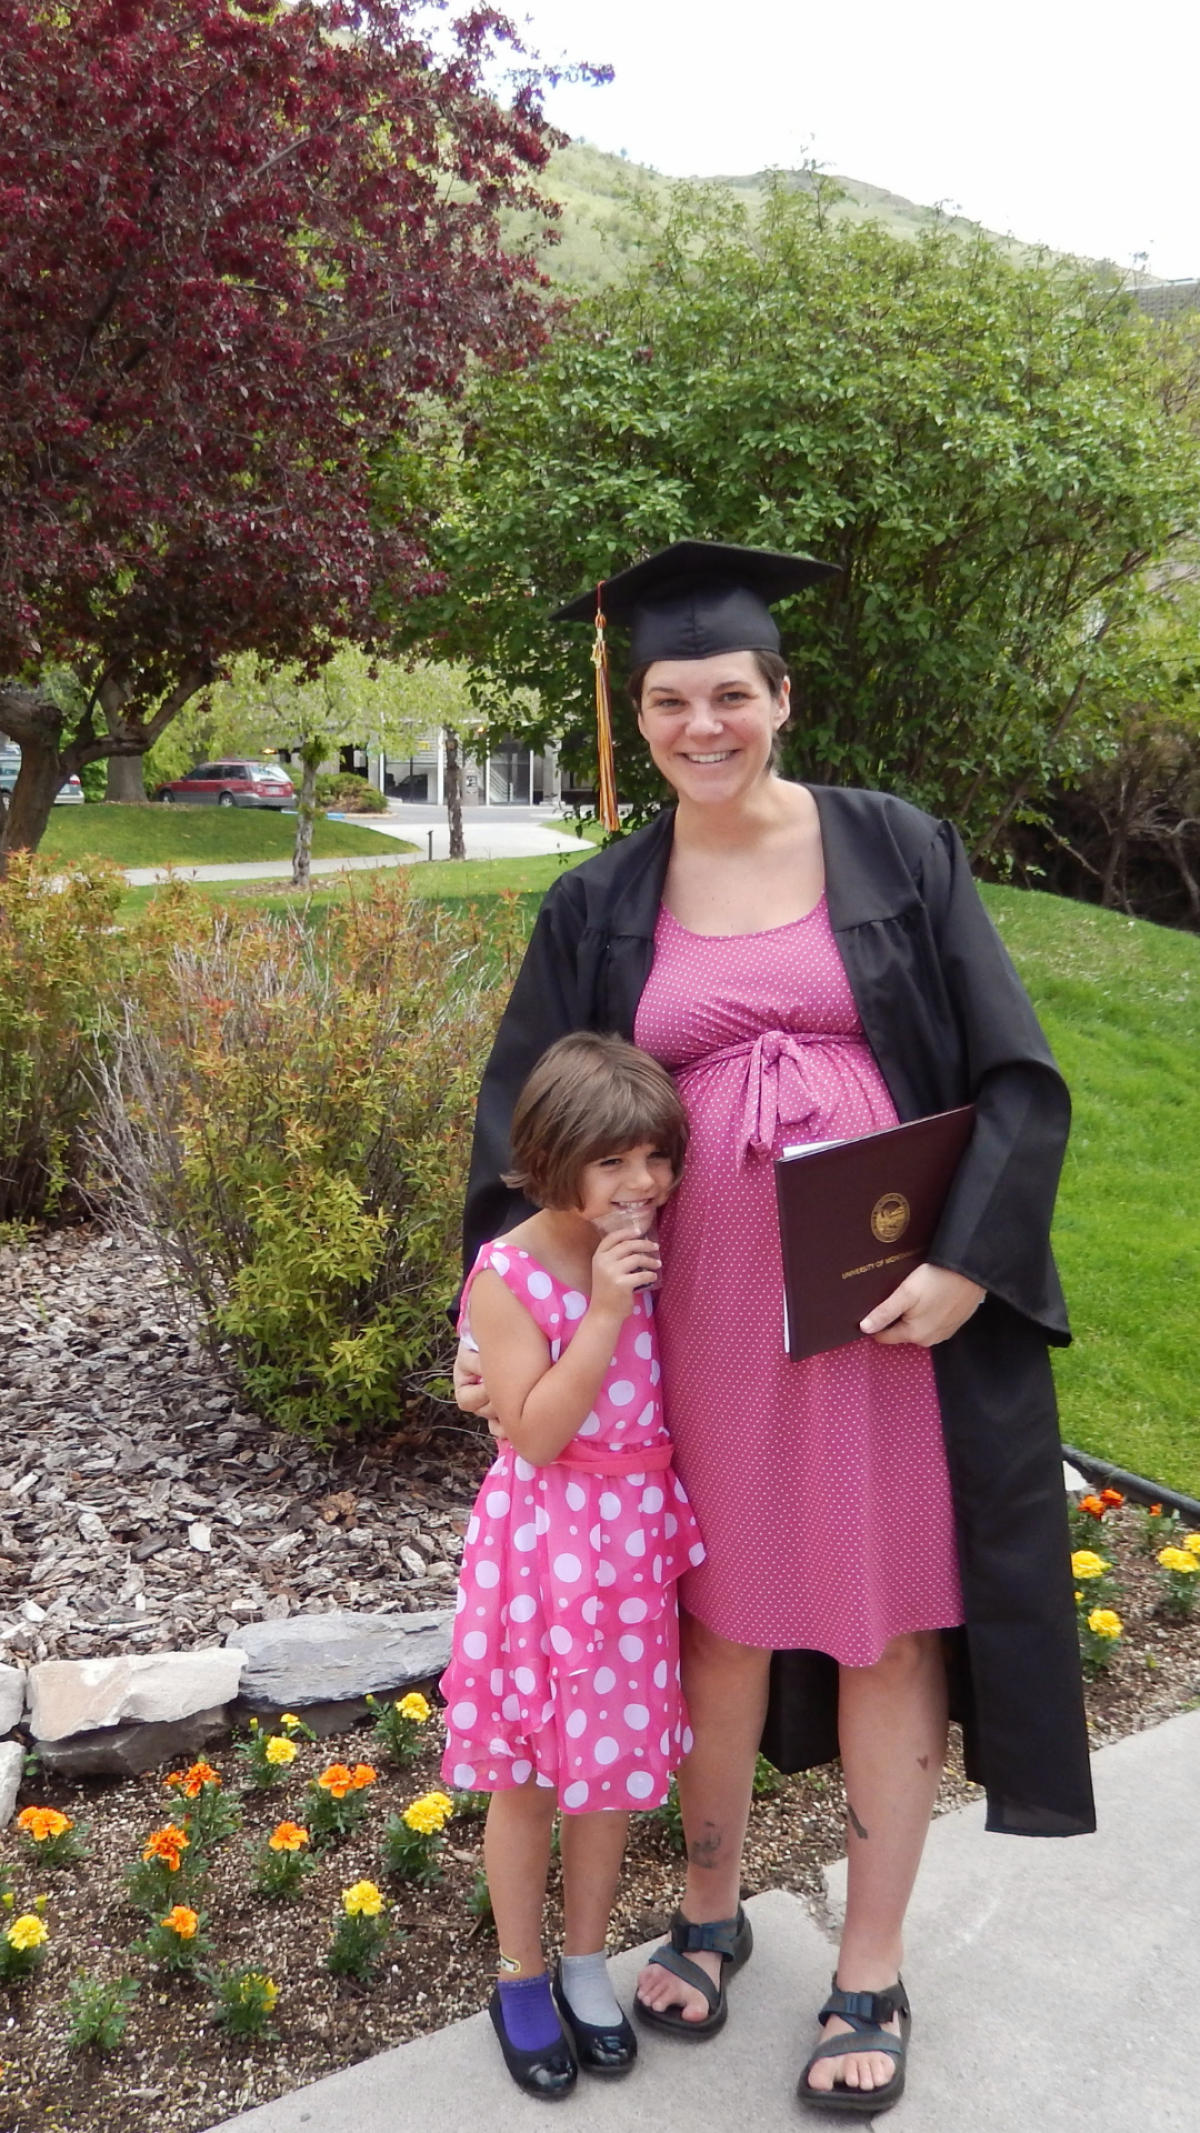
[{"left": 93, "top": 875, "right": 518, "bottom": 1442}]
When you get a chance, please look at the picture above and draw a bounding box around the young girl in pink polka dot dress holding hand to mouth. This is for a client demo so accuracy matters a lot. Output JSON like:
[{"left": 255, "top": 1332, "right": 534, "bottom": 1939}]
[{"left": 441, "top": 1032, "right": 703, "bottom": 2097}]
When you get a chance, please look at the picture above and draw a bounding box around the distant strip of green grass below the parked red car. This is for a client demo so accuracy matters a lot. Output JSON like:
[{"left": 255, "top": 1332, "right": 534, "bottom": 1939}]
[{"left": 40, "top": 800, "right": 413, "bottom": 866}]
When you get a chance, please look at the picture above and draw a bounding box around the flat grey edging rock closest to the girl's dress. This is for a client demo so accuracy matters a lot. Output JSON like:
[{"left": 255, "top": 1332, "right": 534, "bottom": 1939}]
[{"left": 228, "top": 1608, "right": 454, "bottom": 1711}]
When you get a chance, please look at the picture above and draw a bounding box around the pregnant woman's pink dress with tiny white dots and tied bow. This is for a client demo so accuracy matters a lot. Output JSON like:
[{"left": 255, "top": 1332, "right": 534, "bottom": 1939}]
[{"left": 637, "top": 898, "right": 963, "bottom": 1666}]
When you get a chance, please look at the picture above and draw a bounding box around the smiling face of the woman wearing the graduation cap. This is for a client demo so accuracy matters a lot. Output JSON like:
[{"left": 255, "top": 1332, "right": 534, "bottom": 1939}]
[{"left": 637, "top": 653, "right": 791, "bottom": 804}]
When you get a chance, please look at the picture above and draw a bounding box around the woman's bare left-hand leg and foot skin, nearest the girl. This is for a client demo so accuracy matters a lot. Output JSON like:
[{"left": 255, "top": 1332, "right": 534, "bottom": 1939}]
[{"left": 637, "top": 1615, "right": 772, "bottom": 2022}]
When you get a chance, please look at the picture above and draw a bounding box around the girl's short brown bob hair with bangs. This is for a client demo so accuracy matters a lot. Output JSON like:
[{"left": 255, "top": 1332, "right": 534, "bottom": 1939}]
[{"left": 505, "top": 1030, "right": 688, "bottom": 1207}]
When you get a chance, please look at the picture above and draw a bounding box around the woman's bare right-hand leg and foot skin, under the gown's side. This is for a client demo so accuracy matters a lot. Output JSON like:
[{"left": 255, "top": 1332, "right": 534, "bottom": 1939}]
[{"left": 808, "top": 1630, "right": 946, "bottom": 2090}]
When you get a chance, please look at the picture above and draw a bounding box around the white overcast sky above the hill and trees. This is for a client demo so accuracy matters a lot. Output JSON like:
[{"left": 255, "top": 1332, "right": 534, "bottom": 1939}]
[{"left": 509, "top": 0, "right": 1200, "bottom": 277}]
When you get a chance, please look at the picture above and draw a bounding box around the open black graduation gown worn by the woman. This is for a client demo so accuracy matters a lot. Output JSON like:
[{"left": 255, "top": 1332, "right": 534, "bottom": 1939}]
[{"left": 465, "top": 787, "right": 1096, "bottom": 1837}]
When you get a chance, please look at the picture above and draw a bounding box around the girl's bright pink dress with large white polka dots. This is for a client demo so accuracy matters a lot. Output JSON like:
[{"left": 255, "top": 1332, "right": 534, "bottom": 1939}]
[{"left": 441, "top": 1237, "right": 703, "bottom": 1815}]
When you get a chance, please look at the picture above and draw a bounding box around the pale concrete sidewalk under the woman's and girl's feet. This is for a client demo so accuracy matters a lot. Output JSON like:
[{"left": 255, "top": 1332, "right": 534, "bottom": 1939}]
[{"left": 204, "top": 1713, "right": 1200, "bottom": 2133}]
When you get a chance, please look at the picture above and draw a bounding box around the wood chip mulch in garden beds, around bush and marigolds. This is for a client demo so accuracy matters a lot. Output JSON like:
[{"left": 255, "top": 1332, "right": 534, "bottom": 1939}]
[{"left": 0, "top": 1229, "right": 1200, "bottom": 2133}]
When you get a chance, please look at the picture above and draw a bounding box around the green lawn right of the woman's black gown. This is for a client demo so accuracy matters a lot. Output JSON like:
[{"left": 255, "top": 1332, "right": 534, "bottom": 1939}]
[{"left": 985, "top": 889, "right": 1200, "bottom": 1495}]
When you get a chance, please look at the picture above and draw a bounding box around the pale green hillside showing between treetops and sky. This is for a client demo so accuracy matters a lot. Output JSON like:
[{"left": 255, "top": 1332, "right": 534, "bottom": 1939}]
[{"left": 544, "top": 141, "right": 1065, "bottom": 290}]
